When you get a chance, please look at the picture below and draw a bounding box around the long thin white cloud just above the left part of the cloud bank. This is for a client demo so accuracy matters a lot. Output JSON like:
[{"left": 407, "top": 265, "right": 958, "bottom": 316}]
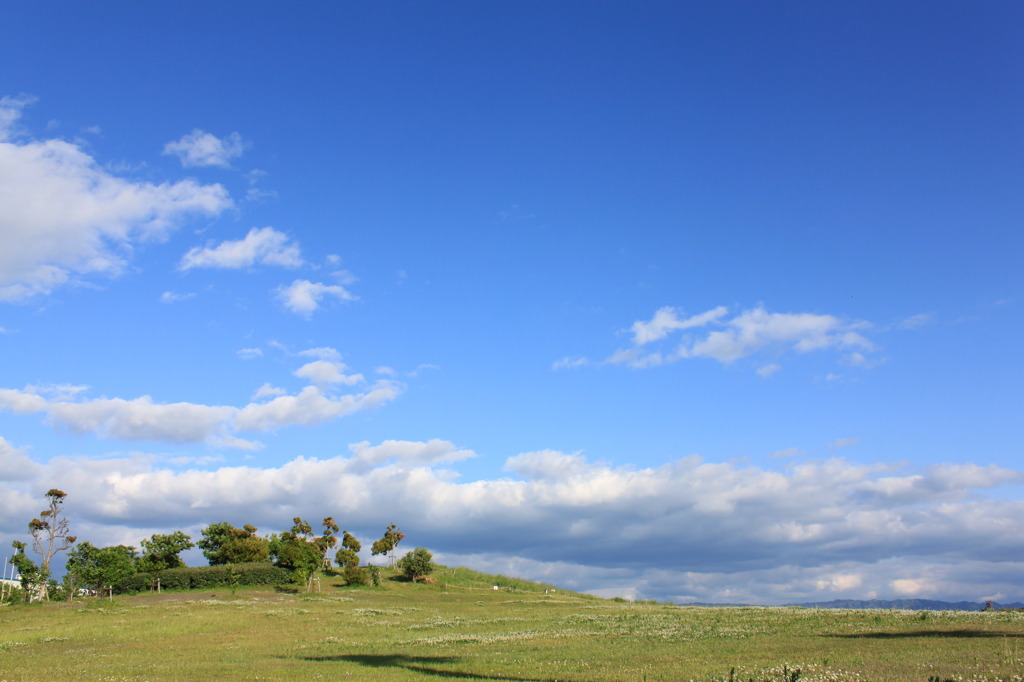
[{"left": 0, "top": 350, "right": 401, "bottom": 450}]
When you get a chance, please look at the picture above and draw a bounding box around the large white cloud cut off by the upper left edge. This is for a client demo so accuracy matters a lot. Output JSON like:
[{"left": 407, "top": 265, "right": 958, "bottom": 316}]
[{"left": 0, "top": 97, "right": 231, "bottom": 301}]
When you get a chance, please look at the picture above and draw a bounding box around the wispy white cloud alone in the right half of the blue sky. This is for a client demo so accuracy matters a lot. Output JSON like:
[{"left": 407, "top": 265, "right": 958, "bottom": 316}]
[{"left": 602, "top": 306, "right": 874, "bottom": 368}]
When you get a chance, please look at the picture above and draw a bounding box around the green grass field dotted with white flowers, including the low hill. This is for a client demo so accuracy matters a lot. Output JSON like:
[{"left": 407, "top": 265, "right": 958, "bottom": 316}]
[{"left": 0, "top": 568, "right": 1024, "bottom": 681}]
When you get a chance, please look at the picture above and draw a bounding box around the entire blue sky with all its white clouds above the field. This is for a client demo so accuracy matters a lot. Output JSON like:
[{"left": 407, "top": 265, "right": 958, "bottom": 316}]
[{"left": 0, "top": 2, "right": 1024, "bottom": 603}]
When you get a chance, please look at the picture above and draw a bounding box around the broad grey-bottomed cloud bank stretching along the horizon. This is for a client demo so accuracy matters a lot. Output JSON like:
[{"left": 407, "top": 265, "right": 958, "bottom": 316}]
[{"left": 0, "top": 439, "right": 1024, "bottom": 603}]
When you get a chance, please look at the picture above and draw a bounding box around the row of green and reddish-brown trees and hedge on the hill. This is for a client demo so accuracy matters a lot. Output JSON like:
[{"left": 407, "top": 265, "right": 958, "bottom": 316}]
[{"left": 4, "top": 488, "right": 433, "bottom": 599}]
